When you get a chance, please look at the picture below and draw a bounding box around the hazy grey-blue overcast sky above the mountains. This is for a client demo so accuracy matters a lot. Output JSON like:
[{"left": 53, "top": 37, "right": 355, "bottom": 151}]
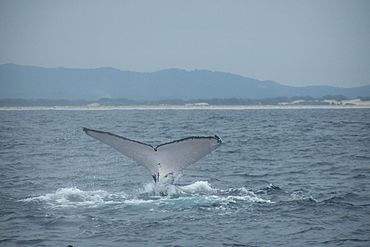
[{"left": 0, "top": 0, "right": 370, "bottom": 87}]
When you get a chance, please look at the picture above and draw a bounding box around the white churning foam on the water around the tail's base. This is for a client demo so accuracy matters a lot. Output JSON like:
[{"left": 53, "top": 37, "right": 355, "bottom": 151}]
[{"left": 21, "top": 181, "right": 272, "bottom": 210}]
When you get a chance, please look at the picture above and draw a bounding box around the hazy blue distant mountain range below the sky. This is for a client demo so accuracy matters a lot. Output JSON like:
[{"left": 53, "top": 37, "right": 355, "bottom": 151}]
[{"left": 0, "top": 64, "right": 370, "bottom": 101}]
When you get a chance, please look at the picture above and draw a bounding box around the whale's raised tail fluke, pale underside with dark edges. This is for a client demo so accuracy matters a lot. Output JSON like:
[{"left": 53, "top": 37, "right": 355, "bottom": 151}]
[{"left": 83, "top": 128, "right": 222, "bottom": 183}]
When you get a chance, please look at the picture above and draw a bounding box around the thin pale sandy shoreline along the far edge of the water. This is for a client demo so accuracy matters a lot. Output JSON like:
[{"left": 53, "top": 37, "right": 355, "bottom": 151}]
[{"left": 0, "top": 105, "right": 370, "bottom": 111}]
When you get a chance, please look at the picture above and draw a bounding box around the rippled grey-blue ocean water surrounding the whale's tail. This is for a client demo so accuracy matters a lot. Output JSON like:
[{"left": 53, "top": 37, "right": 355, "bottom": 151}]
[{"left": 0, "top": 109, "right": 370, "bottom": 247}]
